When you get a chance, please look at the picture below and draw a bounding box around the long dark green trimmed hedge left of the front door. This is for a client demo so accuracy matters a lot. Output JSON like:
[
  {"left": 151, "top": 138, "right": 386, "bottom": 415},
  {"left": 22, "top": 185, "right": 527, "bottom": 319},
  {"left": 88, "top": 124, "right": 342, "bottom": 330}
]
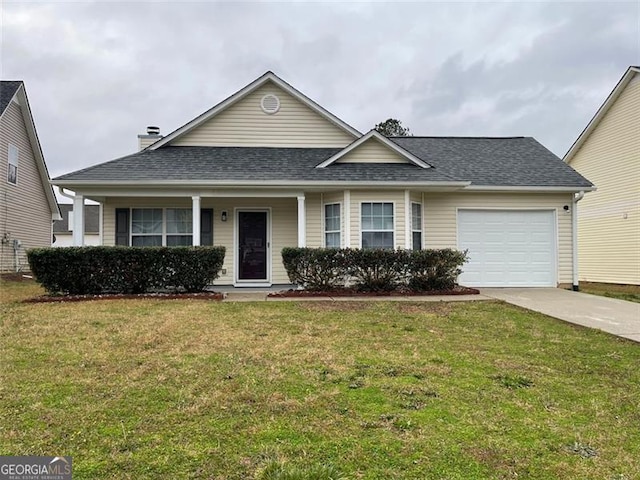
[{"left": 27, "top": 247, "right": 225, "bottom": 295}]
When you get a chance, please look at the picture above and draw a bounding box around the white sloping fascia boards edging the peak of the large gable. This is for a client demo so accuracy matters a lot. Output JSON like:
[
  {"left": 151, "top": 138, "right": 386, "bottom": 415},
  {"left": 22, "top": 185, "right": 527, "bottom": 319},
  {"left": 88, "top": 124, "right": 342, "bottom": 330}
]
[{"left": 146, "top": 72, "right": 362, "bottom": 150}]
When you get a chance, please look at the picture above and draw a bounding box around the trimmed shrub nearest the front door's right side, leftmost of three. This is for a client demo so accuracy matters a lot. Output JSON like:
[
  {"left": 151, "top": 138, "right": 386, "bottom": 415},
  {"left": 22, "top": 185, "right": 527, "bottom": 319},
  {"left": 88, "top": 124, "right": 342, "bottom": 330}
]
[{"left": 282, "top": 247, "right": 348, "bottom": 291}]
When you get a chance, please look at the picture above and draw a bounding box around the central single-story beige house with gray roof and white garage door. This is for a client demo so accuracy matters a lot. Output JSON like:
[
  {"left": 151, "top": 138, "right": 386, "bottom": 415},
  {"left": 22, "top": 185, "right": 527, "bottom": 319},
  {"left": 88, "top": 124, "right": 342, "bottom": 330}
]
[{"left": 53, "top": 72, "right": 593, "bottom": 287}]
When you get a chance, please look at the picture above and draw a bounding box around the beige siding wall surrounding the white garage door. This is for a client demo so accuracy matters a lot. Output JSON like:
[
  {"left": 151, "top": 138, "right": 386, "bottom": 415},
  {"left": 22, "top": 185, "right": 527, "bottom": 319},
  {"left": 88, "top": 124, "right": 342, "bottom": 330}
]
[{"left": 423, "top": 193, "right": 572, "bottom": 283}]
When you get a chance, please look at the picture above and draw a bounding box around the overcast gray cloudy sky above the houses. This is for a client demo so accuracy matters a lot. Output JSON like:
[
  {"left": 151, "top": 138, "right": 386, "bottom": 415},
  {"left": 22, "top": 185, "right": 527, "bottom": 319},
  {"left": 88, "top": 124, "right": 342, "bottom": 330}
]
[{"left": 0, "top": 0, "right": 640, "bottom": 197}]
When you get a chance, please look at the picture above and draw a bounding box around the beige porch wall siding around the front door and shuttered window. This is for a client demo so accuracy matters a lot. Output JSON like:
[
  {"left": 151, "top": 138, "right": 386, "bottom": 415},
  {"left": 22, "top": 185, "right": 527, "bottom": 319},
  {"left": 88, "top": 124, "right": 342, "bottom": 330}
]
[{"left": 103, "top": 197, "right": 298, "bottom": 285}]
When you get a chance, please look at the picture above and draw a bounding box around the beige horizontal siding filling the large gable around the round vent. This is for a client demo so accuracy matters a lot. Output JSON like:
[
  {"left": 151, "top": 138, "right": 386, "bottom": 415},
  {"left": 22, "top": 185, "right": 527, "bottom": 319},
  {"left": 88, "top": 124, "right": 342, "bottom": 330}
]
[{"left": 171, "top": 82, "right": 354, "bottom": 147}]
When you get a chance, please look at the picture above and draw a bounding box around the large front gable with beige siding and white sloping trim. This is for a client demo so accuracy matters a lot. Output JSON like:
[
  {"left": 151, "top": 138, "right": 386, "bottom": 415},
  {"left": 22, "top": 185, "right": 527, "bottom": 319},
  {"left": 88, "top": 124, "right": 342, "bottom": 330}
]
[{"left": 148, "top": 72, "right": 361, "bottom": 150}]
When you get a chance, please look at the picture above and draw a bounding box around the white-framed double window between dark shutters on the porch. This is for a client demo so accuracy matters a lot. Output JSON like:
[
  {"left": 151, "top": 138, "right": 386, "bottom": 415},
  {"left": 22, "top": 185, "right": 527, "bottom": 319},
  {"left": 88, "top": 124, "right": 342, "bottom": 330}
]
[{"left": 131, "top": 208, "right": 193, "bottom": 247}]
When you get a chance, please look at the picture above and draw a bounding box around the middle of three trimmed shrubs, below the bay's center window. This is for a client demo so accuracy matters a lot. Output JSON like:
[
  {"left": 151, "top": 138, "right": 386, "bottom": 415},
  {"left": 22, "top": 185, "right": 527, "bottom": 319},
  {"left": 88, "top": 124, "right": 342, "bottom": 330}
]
[{"left": 347, "top": 249, "right": 410, "bottom": 292}]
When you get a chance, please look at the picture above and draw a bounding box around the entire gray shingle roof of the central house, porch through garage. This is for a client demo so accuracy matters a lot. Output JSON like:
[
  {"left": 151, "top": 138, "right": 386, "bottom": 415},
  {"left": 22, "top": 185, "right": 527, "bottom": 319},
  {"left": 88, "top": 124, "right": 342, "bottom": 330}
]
[{"left": 55, "top": 137, "right": 591, "bottom": 187}]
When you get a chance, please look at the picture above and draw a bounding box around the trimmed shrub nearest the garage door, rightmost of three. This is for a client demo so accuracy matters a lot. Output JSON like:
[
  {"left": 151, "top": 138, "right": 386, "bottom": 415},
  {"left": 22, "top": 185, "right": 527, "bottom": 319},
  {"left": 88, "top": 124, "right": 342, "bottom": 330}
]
[{"left": 407, "top": 248, "right": 468, "bottom": 292}]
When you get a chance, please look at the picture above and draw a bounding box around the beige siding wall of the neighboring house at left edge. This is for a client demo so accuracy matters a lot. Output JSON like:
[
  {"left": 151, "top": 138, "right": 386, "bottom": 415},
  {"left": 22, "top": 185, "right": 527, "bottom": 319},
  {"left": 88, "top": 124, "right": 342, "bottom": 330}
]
[{"left": 0, "top": 102, "right": 52, "bottom": 272}]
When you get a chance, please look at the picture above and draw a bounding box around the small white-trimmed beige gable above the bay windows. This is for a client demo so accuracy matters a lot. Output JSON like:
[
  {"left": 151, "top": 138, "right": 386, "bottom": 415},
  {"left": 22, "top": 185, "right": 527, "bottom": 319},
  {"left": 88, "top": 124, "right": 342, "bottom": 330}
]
[{"left": 316, "top": 130, "right": 431, "bottom": 168}]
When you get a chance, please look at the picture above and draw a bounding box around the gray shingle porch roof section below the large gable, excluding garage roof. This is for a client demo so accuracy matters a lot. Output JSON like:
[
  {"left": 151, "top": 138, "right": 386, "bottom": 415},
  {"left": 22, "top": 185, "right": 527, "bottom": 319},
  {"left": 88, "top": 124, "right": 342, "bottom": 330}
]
[{"left": 56, "top": 147, "right": 455, "bottom": 182}]
